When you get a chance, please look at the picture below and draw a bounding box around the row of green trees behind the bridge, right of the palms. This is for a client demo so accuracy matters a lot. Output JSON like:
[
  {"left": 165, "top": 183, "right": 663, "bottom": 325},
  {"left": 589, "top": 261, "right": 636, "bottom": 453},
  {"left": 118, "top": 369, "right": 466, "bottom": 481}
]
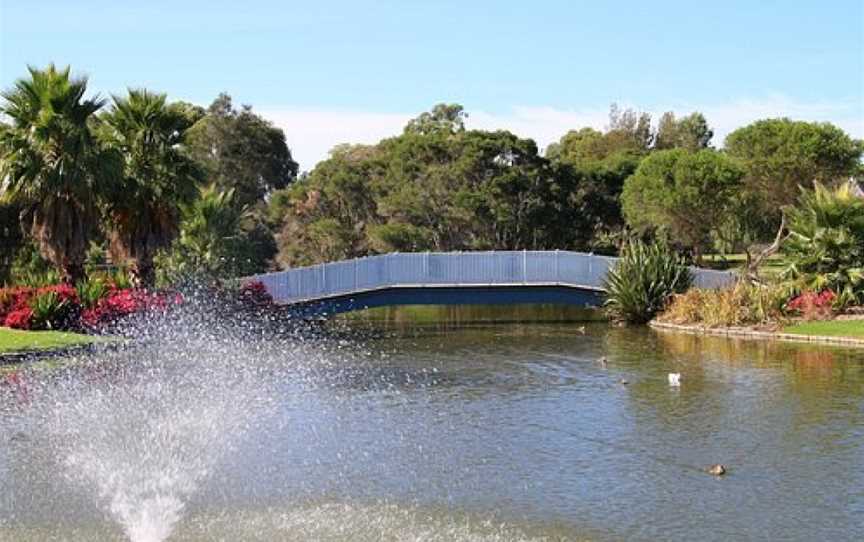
[{"left": 276, "top": 104, "right": 864, "bottom": 266}]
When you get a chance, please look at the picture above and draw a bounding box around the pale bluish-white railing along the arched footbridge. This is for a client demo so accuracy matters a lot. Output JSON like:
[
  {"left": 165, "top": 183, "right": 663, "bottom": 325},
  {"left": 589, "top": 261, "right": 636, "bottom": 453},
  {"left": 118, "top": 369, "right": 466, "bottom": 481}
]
[{"left": 252, "top": 250, "right": 735, "bottom": 303}]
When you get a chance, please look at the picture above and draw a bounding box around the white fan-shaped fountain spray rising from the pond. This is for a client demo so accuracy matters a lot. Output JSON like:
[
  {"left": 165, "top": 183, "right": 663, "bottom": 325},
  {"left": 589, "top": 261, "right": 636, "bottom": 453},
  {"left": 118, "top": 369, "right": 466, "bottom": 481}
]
[{"left": 46, "top": 338, "right": 286, "bottom": 542}]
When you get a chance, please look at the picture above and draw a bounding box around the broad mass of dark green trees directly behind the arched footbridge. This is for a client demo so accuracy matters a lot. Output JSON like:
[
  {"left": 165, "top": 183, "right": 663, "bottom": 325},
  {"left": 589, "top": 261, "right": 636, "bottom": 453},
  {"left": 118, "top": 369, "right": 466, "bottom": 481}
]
[{"left": 271, "top": 106, "right": 571, "bottom": 265}]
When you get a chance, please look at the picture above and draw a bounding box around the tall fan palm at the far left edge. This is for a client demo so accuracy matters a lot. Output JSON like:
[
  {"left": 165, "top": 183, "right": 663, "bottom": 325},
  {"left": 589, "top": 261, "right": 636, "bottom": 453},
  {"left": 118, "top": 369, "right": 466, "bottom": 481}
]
[{"left": 0, "top": 64, "right": 116, "bottom": 282}]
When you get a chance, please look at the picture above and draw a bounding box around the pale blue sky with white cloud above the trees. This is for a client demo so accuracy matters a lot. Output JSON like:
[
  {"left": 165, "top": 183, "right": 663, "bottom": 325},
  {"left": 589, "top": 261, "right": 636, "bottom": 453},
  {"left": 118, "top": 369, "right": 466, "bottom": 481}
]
[{"left": 0, "top": 0, "right": 864, "bottom": 168}]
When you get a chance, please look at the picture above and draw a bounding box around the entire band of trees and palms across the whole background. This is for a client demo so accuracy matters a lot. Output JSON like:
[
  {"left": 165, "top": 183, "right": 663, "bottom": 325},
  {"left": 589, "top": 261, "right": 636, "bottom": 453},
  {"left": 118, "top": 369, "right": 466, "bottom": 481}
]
[{"left": 0, "top": 66, "right": 864, "bottom": 283}]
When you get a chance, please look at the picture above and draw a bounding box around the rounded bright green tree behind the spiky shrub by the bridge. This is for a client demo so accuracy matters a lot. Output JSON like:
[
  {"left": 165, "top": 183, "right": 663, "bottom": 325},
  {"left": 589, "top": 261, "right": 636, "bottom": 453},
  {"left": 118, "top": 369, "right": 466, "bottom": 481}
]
[{"left": 621, "top": 149, "right": 744, "bottom": 259}]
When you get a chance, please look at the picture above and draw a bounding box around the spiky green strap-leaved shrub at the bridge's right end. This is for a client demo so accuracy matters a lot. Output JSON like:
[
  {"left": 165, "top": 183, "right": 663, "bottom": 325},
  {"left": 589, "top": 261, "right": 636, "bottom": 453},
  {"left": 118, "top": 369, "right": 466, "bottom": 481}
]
[{"left": 604, "top": 241, "right": 693, "bottom": 323}]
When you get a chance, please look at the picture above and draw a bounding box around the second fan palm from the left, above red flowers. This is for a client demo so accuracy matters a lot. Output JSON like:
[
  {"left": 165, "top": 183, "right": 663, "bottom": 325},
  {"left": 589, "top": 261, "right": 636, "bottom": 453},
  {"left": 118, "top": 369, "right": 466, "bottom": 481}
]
[{"left": 99, "top": 89, "right": 200, "bottom": 285}]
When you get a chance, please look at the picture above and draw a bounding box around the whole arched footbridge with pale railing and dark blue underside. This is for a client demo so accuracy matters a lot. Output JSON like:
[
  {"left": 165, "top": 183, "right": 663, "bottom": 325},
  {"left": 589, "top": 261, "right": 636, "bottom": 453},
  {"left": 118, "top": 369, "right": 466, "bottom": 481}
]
[{"left": 250, "top": 250, "right": 735, "bottom": 314}]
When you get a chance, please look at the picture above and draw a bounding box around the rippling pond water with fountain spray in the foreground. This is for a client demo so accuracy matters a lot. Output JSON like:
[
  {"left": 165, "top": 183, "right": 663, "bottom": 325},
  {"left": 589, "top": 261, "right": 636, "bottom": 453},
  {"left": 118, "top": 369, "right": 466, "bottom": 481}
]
[{"left": 0, "top": 308, "right": 864, "bottom": 541}]
